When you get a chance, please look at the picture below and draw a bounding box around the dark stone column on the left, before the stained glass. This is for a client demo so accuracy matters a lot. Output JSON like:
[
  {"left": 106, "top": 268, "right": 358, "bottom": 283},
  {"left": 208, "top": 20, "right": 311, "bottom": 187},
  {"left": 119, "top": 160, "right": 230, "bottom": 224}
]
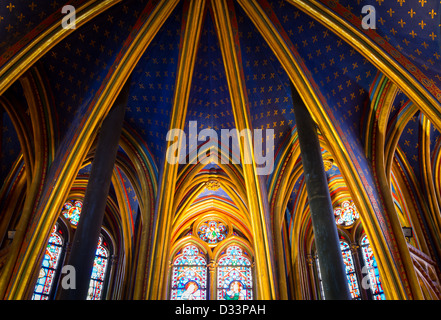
[{"left": 60, "top": 78, "right": 130, "bottom": 300}]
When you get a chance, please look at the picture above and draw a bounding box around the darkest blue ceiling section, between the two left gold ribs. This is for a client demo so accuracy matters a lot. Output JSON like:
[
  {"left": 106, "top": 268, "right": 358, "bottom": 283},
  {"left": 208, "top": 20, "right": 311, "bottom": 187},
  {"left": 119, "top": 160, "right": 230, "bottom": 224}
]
[{"left": 41, "top": 1, "right": 144, "bottom": 141}]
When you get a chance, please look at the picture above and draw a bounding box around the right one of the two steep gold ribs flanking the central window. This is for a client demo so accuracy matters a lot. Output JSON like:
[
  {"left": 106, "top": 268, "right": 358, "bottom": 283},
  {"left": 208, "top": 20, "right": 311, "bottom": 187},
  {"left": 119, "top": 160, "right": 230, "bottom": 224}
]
[{"left": 211, "top": 0, "right": 276, "bottom": 300}]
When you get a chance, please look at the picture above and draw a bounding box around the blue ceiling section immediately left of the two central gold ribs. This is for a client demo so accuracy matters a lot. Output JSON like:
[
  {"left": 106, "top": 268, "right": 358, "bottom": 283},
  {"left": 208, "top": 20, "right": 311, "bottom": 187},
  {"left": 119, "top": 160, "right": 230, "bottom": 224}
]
[{"left": 126, "top": 0, "right": 182, "bottom": 166}]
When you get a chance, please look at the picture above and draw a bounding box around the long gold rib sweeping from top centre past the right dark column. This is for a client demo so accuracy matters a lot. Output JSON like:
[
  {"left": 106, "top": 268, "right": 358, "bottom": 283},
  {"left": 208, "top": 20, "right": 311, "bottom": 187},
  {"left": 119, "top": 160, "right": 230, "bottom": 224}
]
[{"left": 238, "top": 0, "right": 404, "bottom": 299}]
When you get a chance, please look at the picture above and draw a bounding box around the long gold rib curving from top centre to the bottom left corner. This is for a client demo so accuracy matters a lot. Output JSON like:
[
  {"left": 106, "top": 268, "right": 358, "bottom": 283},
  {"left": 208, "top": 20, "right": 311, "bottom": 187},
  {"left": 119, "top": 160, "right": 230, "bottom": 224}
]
[{"left": 2, "top": 0, "right": 178, "bottom": 300}]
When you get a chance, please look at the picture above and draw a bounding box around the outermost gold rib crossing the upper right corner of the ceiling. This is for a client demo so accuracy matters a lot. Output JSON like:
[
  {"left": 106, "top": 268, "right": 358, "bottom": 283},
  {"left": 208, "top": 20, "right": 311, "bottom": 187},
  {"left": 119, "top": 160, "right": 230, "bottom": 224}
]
[{"left": 287, "top": 0, "right": 441, "bottom": 129}]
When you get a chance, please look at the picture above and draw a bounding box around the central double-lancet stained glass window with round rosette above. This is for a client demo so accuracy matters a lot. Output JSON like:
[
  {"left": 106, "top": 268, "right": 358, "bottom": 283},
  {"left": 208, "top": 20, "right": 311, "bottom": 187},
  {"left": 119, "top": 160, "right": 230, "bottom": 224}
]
[{"left": 170, "top": 214, "right": 253, "bottom": 300}]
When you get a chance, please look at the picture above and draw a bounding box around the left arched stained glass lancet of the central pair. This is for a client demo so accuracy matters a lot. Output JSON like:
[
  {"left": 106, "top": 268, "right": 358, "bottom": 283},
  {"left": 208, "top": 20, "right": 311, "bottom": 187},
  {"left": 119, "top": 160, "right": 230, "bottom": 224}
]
[{"left": 170, "top": 244, "right": 207, "bottom": 300}]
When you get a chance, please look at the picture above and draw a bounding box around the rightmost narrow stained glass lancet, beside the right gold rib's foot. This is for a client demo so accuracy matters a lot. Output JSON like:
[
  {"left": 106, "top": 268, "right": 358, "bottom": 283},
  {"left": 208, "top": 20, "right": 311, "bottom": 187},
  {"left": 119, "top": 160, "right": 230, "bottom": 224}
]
[{"left": 361, "top": 235, "right": 386, "bottom": 300}]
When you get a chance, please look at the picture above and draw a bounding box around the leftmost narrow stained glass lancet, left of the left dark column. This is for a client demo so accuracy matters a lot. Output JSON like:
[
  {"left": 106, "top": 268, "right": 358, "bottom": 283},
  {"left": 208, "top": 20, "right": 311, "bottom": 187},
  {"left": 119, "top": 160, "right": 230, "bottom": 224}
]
[{"left": 32, "top": 225, "right": 63, "bottom": 300}]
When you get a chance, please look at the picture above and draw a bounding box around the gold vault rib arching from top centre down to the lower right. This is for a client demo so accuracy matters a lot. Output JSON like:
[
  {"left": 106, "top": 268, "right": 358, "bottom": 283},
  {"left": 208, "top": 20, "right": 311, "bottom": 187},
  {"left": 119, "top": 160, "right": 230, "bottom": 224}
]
[{"left": 235, "top": 0, "right": 410, "bottom": 298}]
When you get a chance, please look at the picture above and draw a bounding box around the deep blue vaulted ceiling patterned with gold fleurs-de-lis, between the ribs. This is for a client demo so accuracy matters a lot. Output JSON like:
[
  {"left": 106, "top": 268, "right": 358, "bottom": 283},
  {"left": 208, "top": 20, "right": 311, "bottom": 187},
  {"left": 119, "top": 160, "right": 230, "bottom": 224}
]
[{"left": 0, "top": 0, "right": 441, "bottom": 214}]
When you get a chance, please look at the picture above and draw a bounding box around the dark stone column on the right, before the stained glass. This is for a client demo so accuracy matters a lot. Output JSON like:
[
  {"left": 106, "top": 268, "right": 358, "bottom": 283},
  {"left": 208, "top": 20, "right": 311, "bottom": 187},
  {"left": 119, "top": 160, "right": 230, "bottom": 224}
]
[{"left": 291, "top": 84, "right": 351, "bottom": 300}]
